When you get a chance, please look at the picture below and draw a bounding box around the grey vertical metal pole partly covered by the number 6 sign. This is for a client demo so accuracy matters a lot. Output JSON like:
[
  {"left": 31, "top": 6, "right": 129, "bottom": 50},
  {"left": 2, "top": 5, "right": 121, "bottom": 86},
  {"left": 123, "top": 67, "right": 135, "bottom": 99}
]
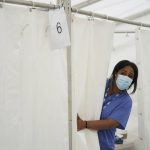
[{"left": 57, "top": 0, "right": 72, "bottom": 150}]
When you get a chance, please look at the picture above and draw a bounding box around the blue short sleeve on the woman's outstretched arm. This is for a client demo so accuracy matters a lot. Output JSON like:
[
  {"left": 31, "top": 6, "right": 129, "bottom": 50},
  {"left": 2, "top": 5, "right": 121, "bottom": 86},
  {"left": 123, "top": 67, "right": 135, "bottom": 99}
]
[{"left": 108, "top": 98, "right": 132, "bottom": 129}]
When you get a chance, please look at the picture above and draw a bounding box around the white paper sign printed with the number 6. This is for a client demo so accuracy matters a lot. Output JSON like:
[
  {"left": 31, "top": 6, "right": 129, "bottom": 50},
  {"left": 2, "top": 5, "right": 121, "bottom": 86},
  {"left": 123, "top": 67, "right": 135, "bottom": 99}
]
[{"left": 49, "top": 8, "right": 70, "bottom": 49}]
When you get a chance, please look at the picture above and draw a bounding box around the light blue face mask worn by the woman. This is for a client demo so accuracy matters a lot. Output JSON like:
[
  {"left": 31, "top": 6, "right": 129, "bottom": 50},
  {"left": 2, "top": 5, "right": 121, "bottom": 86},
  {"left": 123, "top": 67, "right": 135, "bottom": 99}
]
[{"left": 116, "top": 74, "right": 133, "bottom": 90}]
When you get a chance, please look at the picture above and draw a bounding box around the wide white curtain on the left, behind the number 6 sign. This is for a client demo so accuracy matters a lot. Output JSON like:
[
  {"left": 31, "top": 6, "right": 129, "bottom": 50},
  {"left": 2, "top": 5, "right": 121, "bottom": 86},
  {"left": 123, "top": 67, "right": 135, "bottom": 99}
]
[{"left": 0, "top": 6, "right": 68, "bottom": 150}]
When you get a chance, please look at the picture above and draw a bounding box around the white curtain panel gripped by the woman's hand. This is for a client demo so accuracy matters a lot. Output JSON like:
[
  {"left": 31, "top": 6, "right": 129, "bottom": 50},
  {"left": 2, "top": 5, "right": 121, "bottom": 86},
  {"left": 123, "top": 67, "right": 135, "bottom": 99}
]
[{"left": 72, "top": 16, "right": 114, "bottom": 150}]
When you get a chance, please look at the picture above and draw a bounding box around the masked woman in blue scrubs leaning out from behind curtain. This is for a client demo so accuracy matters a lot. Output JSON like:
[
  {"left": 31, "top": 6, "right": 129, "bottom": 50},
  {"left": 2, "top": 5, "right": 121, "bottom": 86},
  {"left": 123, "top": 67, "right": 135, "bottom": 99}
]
[{"left": 77, "top": 60, "right": 138, "bottom": 150}]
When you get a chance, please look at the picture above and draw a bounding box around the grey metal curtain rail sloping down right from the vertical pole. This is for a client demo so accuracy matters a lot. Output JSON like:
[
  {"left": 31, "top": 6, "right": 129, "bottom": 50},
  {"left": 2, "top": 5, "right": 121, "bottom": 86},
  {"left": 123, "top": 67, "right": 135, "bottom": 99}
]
[{"left": 72, "top": 8, "right": 150, "bottom": 28}]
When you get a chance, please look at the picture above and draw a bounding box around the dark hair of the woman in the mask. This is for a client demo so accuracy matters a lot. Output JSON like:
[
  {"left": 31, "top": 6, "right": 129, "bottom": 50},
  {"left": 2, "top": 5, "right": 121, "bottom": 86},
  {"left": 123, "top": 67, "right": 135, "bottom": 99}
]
[{"left": 111, "top": 60, "right": 138, "bottom": 93}]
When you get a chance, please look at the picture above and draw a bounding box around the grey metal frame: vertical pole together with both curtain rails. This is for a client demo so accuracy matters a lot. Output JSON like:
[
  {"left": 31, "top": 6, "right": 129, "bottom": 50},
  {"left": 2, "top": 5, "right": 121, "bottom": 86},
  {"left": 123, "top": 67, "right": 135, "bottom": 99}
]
[{"left": 0, "top": 0, "right": 150, "bottom": 150}]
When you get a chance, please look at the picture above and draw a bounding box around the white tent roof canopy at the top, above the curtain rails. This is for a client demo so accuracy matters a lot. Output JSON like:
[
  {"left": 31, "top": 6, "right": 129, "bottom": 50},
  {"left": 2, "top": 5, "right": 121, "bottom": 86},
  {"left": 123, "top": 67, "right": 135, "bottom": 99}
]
[{"left": 31, "top": 0, "right": 150, "bottom": 20}]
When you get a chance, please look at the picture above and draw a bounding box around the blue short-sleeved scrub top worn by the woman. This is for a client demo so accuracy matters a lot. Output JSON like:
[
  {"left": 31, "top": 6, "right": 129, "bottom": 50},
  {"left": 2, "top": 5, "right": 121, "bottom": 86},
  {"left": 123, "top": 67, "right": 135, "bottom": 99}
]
[{"left": 98, "top": 80, "right": 132, "bottom": 150}]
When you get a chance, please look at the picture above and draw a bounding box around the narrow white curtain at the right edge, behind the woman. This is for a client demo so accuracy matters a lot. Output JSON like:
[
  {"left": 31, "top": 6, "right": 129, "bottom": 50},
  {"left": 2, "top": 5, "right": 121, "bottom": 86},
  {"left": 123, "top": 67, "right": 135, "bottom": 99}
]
[{"left": 136, "top": 30, "right": 150, "bottom": 150}]
